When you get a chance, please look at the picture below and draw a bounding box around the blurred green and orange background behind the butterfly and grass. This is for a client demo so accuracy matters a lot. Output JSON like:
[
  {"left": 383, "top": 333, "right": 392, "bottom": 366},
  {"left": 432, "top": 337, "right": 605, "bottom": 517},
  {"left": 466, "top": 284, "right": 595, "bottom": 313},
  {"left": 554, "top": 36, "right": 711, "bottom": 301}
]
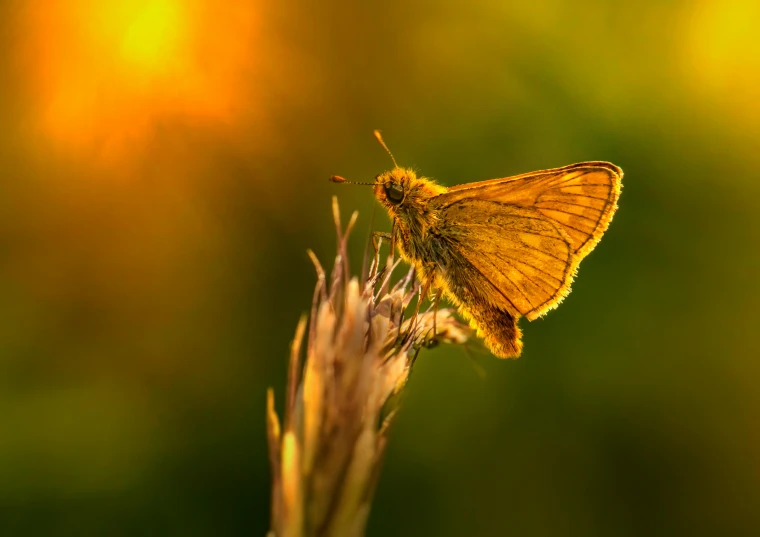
[{"left": 0, "top": 0, "right": 760, "bottom": 537}]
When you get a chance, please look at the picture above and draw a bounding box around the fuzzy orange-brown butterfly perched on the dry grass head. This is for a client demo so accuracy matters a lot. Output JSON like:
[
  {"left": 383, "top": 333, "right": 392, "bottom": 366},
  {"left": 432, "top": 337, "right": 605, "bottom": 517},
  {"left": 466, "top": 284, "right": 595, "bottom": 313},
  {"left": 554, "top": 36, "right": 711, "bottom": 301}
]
[{"left": 374, "top": 162, "right": 623, "bottom": 358}]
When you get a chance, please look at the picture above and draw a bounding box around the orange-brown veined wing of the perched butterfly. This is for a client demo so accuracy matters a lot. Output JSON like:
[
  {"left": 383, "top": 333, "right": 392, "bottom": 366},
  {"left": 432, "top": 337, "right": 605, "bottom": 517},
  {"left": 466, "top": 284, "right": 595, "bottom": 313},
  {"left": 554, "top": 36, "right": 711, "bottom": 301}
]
[{"left": 430, "top": 162, "right": 623, "bottom": 320}]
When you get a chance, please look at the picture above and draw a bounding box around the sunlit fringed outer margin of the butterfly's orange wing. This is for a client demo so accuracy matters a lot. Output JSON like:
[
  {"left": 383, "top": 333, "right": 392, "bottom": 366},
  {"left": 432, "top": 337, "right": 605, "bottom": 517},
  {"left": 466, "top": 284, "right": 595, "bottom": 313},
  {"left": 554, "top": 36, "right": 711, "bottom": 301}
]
[{"left": 525, "top": 161, "right": 623, "bottom": 321}]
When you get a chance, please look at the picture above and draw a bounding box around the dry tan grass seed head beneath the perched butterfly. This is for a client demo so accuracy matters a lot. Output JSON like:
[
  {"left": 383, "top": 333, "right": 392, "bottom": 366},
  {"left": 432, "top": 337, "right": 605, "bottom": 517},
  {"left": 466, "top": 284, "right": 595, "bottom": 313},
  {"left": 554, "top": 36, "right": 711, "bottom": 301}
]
[{"left": 267, "top": 198, "right": 469, "bottom": 537}]
